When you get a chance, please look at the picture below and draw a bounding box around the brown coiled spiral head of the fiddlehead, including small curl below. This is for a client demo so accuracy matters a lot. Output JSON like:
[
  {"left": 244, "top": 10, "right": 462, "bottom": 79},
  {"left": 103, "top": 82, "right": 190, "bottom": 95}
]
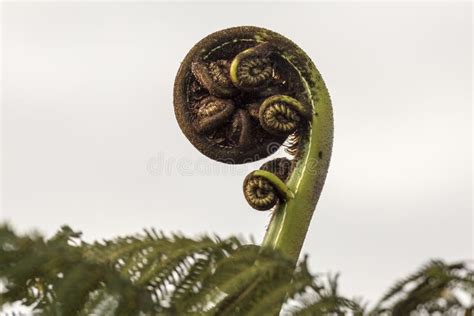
[{"left": 174, "top": 27, "right": 326, "bottom": 210}]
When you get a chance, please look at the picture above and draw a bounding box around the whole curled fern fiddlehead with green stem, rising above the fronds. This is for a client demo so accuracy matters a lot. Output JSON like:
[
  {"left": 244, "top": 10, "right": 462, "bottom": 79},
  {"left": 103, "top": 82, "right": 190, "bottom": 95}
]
[{"left": 174, "top": 26, "right": 333, "bottom": 261}]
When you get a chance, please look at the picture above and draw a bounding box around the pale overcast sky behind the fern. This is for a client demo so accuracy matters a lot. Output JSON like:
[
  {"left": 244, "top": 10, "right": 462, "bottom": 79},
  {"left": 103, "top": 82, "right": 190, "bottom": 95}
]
[{"left": 1, "top": 2, "right": 473, "bottom": 301}]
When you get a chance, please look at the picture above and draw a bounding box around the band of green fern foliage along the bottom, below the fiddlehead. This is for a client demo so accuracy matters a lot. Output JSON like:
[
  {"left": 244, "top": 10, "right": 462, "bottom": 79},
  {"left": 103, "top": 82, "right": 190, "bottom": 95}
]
[{"left": 0, "top": 225, "right": 474, "bottom": 316}]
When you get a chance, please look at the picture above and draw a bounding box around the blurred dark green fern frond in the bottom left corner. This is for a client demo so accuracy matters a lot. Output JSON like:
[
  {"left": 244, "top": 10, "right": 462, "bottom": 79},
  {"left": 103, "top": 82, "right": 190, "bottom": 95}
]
[{"left": 0, "top": 226, "right": 153, "bottom": 315}]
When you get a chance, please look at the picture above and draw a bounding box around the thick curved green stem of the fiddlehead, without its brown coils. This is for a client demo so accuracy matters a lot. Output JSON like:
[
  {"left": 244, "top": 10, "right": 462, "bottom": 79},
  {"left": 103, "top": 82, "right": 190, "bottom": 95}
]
[{"left": 259, "top": 32, "right": 333, "bottom": 263}]
